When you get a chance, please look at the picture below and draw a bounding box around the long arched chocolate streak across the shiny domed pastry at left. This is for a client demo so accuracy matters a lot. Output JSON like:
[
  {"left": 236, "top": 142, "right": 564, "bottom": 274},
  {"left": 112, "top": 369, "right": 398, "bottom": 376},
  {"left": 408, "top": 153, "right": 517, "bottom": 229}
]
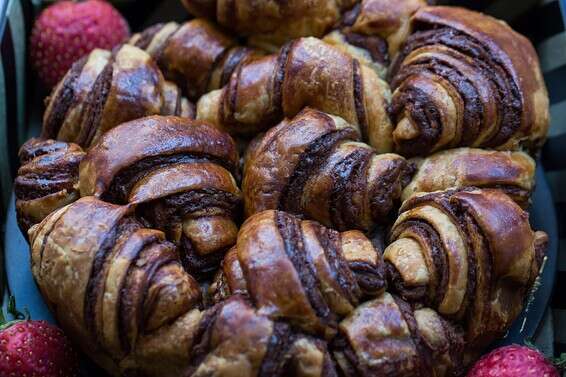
[{"left": 102, "top": 153, "right": 237, "bottom": 204}]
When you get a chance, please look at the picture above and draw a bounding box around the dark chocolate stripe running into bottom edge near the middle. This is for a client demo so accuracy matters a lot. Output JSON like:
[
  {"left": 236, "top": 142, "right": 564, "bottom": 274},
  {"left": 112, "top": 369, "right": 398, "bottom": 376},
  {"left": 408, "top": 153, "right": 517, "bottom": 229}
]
[{"left": 258, "top": 322, "right": 295, "bottom": 377}]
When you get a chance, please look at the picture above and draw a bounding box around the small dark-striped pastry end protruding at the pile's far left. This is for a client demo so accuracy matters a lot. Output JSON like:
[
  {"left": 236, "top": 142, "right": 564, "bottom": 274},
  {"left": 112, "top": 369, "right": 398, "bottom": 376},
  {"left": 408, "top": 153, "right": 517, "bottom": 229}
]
[{"left": 14, "top": 138, "right": 84, "bottom": 234}]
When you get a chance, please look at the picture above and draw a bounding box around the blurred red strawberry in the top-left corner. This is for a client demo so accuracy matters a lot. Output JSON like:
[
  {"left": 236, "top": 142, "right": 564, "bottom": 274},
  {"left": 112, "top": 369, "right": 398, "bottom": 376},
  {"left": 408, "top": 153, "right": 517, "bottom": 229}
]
[{"left": 31, "top": 0, "right": 130, "bottom": 87}]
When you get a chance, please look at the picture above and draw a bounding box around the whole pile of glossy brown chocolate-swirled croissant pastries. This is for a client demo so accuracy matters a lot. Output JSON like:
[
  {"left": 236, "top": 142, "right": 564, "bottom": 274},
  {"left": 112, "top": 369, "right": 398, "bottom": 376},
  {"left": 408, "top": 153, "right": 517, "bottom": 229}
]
[{"left": 15, "top": 0, "right": 548, "bottom": 377}]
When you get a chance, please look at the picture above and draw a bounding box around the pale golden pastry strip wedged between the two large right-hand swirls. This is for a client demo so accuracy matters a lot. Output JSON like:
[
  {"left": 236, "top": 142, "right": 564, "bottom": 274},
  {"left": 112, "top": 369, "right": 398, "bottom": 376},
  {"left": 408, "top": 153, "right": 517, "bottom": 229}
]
[{"left": 401, "top": 148, "right": 536, "bottom": 208}]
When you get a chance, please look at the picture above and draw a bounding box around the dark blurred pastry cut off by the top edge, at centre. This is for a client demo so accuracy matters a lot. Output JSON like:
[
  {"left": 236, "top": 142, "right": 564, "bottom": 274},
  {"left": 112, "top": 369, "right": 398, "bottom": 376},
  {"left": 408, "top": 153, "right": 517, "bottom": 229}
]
[{"left": 181, "top": 0, "right": 356, "bottom": 51}]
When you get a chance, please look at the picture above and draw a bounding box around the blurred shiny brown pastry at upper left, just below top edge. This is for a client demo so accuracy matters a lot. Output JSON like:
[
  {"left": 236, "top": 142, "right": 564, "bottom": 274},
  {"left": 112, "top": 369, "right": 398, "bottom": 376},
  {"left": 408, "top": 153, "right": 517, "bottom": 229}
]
[{"left": 128, "top": 19, "right": 257, "bottom": 100}]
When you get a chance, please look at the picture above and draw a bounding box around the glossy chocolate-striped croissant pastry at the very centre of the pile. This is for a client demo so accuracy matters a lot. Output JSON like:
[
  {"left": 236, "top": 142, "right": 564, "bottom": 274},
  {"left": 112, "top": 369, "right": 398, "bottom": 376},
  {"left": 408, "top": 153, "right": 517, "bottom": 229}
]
[{"left": 242, "top": 108, "right": 412, "bottom": 231}]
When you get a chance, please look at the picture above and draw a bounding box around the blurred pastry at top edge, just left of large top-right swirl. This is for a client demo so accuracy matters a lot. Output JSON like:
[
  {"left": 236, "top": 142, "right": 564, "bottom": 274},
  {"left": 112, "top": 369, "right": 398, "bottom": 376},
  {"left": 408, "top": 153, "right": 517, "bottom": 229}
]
[{"left": 323, "top": 0, "right": 427, "bottom": 77}]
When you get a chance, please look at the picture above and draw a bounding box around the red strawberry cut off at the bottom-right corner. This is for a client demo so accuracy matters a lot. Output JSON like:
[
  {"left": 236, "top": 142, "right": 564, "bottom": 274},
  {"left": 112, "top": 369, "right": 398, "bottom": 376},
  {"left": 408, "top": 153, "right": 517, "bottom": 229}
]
[{"left": 467, "top": 344, "right": 560, "bottom": 377}]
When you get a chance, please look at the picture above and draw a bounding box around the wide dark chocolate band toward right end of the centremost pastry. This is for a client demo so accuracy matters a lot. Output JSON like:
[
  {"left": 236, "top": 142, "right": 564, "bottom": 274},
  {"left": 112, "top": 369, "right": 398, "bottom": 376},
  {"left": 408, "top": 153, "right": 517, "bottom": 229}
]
[{"left": 330, "top": 148, "right": 373, "bottom": 230}]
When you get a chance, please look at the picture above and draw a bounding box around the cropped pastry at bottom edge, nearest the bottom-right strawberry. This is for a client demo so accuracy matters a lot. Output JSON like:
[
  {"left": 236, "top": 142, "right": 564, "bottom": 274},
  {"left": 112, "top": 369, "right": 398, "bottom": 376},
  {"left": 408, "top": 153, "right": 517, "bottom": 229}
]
[{"left": 333, "top": 293, "right": 464, "bottom": 377}]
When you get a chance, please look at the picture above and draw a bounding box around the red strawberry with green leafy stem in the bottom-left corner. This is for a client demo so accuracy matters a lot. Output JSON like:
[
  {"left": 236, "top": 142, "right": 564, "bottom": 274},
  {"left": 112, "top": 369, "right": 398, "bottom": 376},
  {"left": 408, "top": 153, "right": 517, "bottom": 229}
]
[{"left": 0, "top": 298, "right": 79, "bottom": 377}]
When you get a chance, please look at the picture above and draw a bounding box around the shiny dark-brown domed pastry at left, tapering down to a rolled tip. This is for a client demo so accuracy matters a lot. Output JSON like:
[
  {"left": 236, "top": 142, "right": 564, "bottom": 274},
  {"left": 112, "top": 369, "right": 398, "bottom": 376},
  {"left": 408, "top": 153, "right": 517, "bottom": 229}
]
[{"left": 80, "top": 116, "right": 241, "bottom": 278}]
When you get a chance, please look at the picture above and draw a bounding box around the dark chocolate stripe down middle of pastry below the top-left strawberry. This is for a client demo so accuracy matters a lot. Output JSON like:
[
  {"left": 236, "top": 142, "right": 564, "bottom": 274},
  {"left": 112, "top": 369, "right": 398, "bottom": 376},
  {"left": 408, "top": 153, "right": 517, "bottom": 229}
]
[{"left": 77, "top": 59, "right": 114, "bottom": 146}]
